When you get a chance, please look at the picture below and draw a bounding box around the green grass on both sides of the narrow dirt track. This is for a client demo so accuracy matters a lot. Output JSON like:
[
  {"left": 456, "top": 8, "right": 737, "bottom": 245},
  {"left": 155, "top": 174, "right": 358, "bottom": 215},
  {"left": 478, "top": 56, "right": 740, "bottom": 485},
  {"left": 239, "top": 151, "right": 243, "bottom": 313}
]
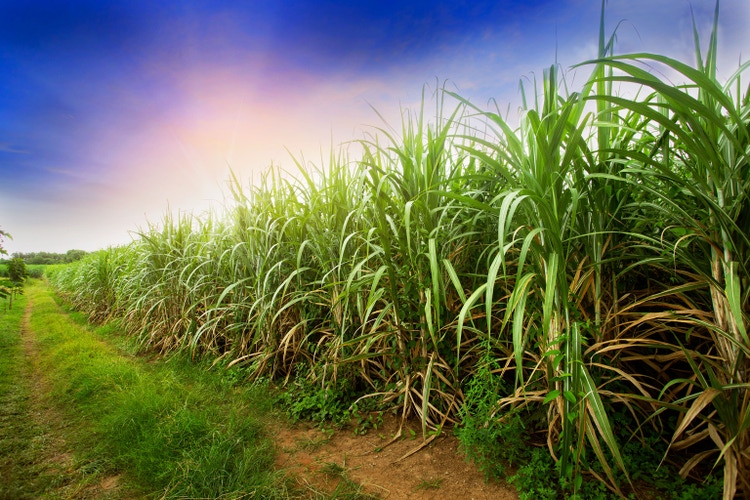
[{"left": 0, "top": 282, "right": 300, "bottom": 498}]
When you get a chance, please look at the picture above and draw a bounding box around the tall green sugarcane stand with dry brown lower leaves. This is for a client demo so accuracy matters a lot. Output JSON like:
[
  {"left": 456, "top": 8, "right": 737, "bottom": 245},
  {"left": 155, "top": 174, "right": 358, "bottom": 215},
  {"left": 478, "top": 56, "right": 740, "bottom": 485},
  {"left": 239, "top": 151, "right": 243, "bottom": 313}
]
[{"left": 50, "top": 4, "right": 750, "bottom": 498}]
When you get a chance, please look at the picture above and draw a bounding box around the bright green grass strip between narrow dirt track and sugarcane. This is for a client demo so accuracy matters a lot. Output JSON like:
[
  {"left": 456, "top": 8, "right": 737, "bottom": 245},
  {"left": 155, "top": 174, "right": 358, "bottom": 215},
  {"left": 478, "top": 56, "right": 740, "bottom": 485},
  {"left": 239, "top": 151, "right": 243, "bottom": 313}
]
[{"left": 8, "top": 282, "right": 300, "bottom": 498}]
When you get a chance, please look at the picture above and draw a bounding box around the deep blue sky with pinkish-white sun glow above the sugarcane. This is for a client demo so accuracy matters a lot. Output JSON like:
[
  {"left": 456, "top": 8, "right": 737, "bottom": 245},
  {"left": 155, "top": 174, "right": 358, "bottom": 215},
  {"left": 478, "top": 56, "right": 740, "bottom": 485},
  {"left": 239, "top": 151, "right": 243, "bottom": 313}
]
[{"left": 0, "top": 0, "right": 750, "bottom": 252}]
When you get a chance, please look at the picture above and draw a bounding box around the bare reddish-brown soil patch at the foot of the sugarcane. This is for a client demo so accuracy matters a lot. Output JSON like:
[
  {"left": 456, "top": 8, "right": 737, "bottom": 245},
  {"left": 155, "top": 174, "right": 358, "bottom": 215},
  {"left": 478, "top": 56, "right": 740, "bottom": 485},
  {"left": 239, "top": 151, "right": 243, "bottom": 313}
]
[{"left": 274, "top": 415, "right": 518, "bottom": 500}]
